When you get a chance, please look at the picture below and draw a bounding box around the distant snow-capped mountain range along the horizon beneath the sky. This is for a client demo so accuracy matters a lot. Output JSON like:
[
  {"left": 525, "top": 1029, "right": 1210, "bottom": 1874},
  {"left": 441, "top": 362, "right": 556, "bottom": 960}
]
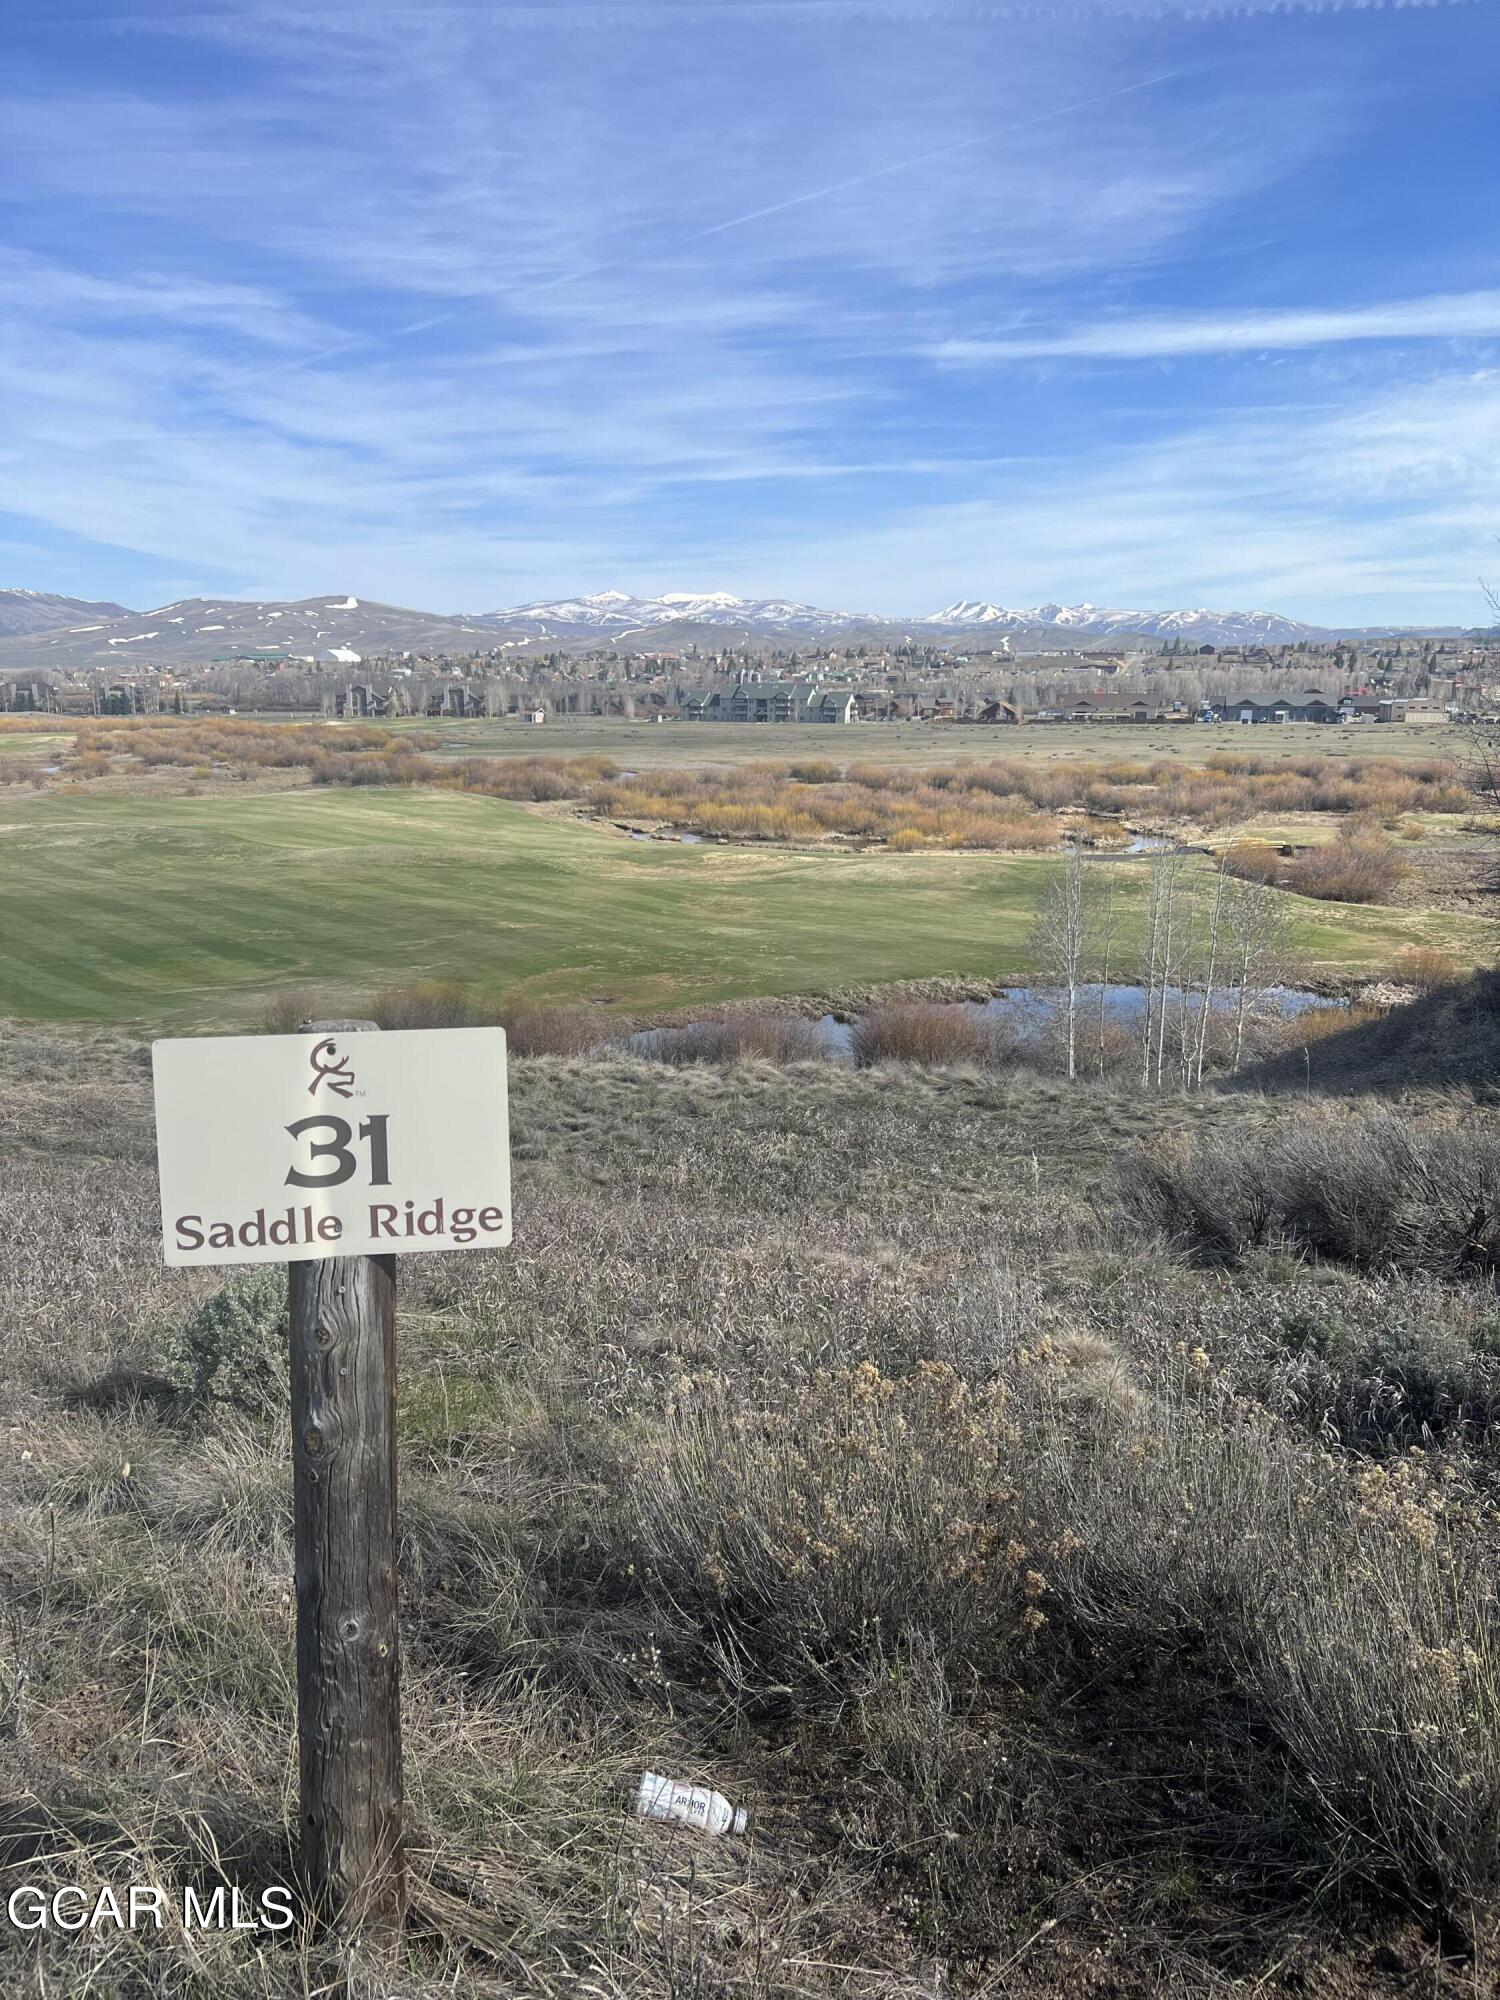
[{"left": 0, "top": 590, "right": 1480, "bottom": 672}]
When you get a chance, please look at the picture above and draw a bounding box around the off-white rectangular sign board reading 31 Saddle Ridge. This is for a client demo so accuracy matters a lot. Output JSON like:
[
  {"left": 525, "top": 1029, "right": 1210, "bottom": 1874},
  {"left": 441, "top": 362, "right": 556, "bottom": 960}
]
[{"left": 152, "top": 1028, "right": 510, "bottom": 1264}]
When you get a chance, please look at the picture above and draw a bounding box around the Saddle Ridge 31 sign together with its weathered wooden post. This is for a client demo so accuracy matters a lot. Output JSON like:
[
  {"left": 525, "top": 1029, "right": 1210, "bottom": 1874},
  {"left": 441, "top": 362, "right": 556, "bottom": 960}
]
[{"left": 152, "top": 1022, "right": 510, "bottom": 1938}]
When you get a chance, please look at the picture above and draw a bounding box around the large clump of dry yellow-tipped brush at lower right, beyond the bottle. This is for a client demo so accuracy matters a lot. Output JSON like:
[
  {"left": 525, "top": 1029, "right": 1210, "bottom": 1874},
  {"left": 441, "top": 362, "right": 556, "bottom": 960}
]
[{"left": 612, "top": 1342, "right": 1500, "bottom": 1922}]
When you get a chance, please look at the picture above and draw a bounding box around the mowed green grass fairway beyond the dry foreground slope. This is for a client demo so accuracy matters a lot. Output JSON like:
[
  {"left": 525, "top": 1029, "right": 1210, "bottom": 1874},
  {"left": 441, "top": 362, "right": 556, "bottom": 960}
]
[{"left": 0, "top": 788, "right": 1496, "bottom": 1026}]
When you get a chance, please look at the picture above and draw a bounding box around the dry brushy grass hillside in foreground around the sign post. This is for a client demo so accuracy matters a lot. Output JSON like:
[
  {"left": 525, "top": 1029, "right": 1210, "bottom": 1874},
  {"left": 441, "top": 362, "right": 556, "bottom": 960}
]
[{"left": 0, "top": 1030, "right": 1500, "bottom": 2000}]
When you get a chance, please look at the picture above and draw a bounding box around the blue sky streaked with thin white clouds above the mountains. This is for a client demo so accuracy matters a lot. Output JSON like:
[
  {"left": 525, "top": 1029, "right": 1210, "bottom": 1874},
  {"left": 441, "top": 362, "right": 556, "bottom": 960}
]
[{"left": 0, "top": 0, "right": 1500, "bottom": 624}]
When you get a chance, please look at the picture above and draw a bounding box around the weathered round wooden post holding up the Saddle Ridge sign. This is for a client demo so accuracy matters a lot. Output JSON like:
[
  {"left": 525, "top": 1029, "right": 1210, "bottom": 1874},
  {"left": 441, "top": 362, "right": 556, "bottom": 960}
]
[{"left": 286, "top": 1020, "right": 406, "bottom": 1938}]
